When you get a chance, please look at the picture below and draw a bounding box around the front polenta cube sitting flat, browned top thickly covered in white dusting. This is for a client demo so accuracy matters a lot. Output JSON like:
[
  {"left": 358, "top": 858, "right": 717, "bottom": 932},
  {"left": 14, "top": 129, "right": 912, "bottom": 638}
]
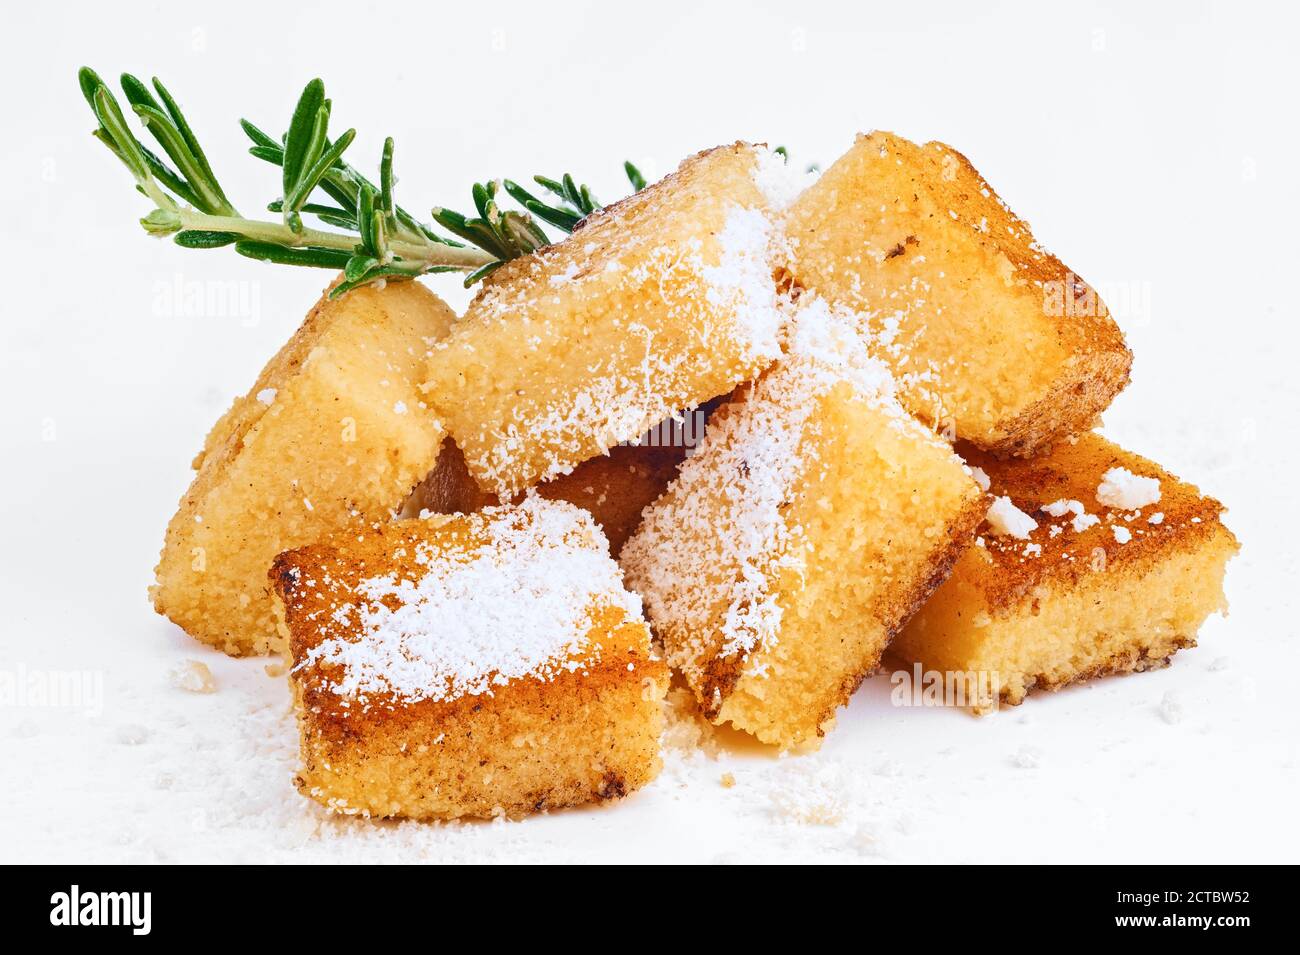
[{"left": 270, "top": 496, "right": 668, "bottom": 820}]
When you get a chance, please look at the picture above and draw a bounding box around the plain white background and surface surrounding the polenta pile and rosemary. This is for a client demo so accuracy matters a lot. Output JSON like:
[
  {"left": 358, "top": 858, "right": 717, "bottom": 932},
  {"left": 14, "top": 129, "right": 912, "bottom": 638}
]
[{"left": 0, "top": 1, "right": 1300, "bottom": 861}]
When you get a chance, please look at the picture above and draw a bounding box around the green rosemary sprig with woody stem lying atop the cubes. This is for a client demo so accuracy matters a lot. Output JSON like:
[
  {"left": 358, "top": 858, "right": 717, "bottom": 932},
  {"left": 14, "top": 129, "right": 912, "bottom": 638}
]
[{"left": 78, "top": 68, "right": 645, "bottom": 296}]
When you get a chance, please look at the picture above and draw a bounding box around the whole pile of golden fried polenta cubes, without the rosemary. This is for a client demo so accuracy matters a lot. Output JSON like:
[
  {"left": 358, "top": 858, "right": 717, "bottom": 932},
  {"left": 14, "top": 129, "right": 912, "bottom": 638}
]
[{"left": 153, "top": 133, "right": 1236, "bottom": 819}]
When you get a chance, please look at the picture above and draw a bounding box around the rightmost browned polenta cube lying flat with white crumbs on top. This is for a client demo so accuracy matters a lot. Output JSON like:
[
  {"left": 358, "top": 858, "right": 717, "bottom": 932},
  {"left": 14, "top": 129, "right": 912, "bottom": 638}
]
[{"left": 893, "top": 433, "right": 1238, "bottom": 709}]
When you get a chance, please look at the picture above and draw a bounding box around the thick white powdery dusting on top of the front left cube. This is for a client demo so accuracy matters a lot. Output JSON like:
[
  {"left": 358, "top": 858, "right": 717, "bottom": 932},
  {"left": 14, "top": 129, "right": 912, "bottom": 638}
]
[{"left": 298, "top": 496, "right": 641, "bottom": 702}]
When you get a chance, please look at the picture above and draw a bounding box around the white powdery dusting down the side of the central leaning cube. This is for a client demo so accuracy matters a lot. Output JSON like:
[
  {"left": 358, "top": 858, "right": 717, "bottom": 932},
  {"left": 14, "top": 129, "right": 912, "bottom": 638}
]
[{"left": 620, "top": 295, "right": 939, "bottom": 672}]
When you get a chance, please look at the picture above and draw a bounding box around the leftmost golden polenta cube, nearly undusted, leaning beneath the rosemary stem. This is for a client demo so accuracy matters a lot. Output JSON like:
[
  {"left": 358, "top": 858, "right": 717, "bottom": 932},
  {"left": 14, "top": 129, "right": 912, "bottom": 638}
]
[{"left": 150, "top": 282, "right": 455, "bottom": 655}]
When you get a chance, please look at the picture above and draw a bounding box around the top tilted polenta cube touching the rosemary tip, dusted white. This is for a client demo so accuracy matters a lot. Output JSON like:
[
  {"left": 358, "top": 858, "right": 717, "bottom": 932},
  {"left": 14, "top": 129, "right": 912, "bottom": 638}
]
[{"left": 426, "top": 143, "right": 785, "bottom": 500}]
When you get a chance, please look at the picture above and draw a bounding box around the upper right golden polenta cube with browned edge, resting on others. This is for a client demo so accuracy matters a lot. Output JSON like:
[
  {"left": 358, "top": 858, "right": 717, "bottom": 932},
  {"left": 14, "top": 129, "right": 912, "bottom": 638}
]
[{"left": 785, "top": 133, "right": 1132, "bottom": 455}]
